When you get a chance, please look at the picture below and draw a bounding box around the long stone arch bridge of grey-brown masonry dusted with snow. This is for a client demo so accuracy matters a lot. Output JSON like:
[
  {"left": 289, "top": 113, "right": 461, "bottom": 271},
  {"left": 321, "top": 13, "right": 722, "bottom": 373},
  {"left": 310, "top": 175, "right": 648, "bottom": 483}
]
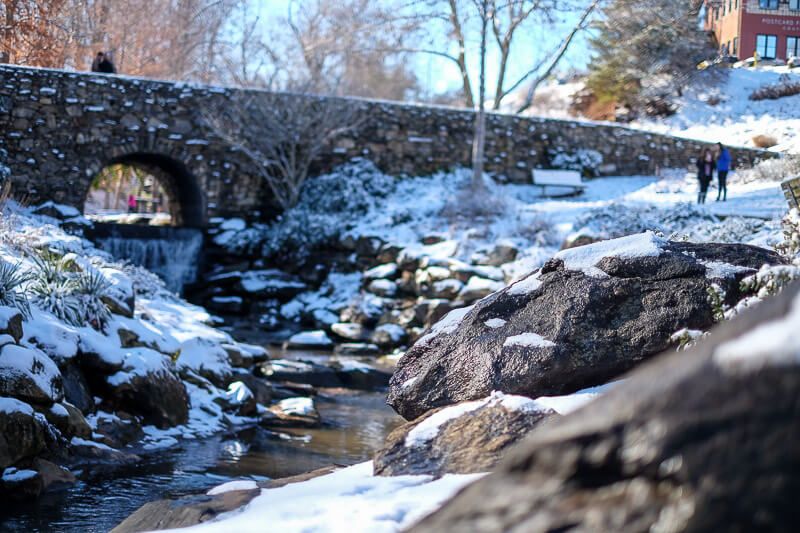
[{"left": 0, "top": 65, "right": 770, "bottom": 227}]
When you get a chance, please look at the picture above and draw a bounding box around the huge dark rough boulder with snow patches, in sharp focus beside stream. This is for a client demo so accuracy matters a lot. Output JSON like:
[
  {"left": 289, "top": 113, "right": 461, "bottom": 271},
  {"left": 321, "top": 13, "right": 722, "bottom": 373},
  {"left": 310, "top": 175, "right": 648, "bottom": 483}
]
[{"left": 388, "top": 233, "right": 782, "bottom": 420}]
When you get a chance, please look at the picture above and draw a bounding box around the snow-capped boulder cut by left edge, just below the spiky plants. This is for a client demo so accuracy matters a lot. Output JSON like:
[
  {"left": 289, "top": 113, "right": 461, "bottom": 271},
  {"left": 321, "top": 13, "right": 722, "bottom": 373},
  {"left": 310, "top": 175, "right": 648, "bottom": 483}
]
[{"left": 0, "top": 344, "right": 64, "bottom": 406}]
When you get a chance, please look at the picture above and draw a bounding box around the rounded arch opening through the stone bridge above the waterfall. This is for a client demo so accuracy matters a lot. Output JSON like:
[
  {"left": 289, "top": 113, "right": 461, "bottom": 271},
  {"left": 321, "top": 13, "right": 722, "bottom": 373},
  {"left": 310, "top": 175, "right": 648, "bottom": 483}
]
[{"left": 84, "top": 152, "right": 207, "bottom": 228}]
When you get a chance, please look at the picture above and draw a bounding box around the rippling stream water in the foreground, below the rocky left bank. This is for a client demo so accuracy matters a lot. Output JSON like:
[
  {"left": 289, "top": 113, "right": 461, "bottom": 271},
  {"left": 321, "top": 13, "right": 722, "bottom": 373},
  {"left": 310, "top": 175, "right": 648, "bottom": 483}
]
[{"left": 0, "top": 390, "right": 402, "bottom": 533}]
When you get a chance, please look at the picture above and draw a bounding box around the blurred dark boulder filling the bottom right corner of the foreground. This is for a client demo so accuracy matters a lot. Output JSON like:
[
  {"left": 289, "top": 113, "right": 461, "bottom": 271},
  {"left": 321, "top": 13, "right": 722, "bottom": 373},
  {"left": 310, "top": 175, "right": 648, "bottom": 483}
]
[{"left": 412, "top": 284, "right": 800, "bottom": 533}]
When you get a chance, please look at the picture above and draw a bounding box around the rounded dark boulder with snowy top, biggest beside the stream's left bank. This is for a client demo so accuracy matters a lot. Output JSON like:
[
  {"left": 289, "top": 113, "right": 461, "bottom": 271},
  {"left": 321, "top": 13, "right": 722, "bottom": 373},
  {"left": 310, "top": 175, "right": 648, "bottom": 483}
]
[{"left": 106, "top": 348, "right": 189, "bottom": 428}]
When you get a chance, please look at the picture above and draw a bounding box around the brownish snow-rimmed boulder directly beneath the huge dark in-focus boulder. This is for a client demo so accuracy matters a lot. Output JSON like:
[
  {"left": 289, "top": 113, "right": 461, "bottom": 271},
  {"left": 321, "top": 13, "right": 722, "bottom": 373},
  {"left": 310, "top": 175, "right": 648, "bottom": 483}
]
[{"left": 373, "top": 393, "right": 555, "bottom": 477}]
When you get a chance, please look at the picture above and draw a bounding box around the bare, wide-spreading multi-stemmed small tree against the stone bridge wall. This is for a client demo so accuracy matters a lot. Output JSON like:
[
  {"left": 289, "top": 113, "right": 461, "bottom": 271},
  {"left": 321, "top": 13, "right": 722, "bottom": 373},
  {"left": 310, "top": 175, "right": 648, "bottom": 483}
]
[{"left": 205, "top": 93, "right": 364, "bottom": 209}]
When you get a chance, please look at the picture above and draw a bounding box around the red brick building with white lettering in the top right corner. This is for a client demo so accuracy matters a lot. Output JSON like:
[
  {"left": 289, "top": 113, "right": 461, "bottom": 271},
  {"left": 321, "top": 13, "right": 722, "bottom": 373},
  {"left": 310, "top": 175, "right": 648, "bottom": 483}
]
[{"left": 705, "top": 0, "right": 800, "bottom": 59}]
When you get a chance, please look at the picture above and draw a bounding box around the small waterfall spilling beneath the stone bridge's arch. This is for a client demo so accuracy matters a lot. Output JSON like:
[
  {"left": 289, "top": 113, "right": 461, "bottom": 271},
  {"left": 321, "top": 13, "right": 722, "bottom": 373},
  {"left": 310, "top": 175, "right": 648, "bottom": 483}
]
[{"left": 93, "top": 225, "right": 203, "bottom": 294}]
